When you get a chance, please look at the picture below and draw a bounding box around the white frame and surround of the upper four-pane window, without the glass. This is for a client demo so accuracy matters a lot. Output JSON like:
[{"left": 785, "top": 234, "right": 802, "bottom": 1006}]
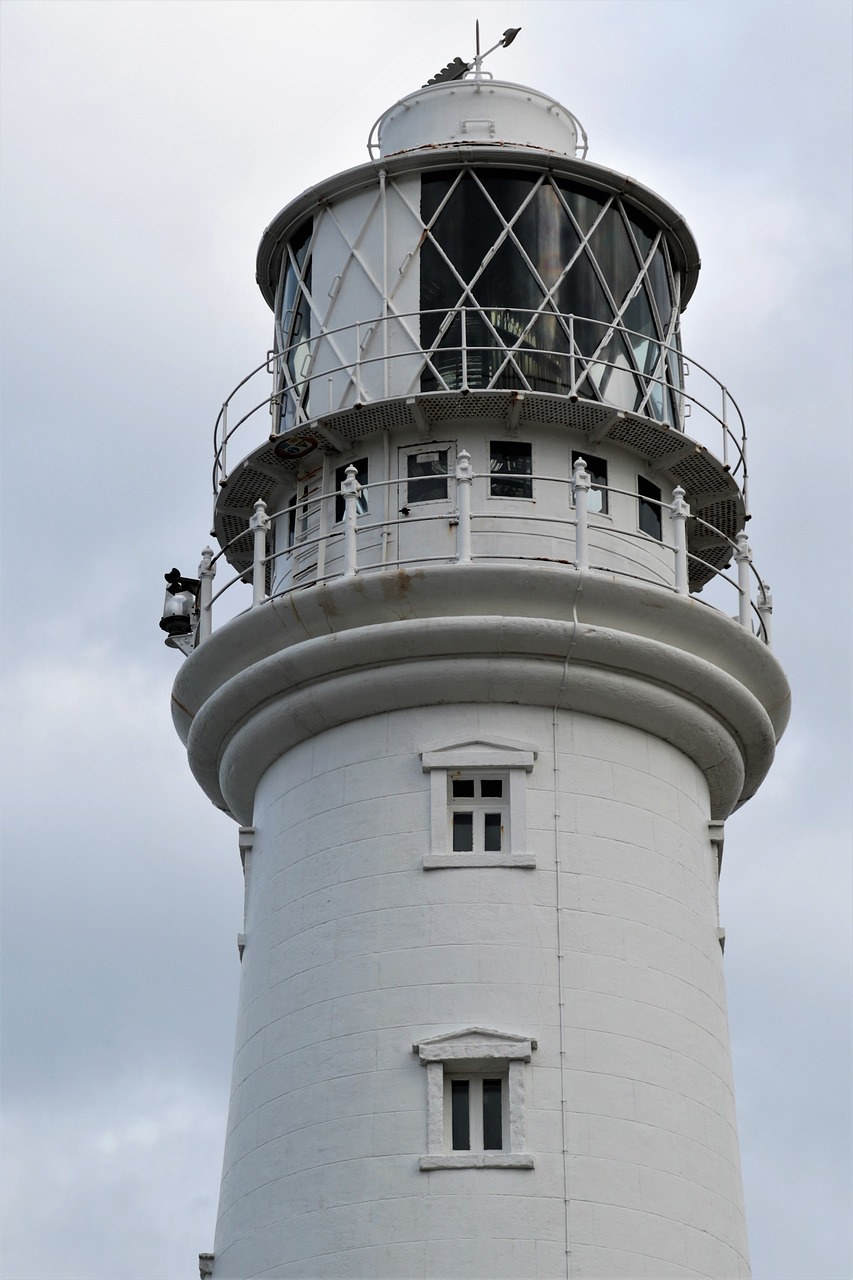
[{"left": 420, "top": 739, "right": 537, "bottom": 870}]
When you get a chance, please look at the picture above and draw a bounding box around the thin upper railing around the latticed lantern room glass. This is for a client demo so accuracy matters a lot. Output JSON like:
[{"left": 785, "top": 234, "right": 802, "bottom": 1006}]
[{"left": 213, "top": 307, "right": 748, "bottom": 500}]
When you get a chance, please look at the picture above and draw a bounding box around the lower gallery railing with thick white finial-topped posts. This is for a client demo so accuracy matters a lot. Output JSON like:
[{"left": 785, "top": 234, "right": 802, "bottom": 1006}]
[{"left": 188, "top": 449, "right": 772, "bottom": 644}]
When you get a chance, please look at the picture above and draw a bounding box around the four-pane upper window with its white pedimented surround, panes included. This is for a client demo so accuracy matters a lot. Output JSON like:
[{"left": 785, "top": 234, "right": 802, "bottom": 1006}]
[{"left": 421, "top": 739, "right": 537, "bottom": 869}]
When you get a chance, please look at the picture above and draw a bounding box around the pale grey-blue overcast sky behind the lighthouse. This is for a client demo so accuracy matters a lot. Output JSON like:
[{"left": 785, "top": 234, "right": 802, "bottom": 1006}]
[{"left": 0, "top": 0, "right": 853, "bottom": 1280}]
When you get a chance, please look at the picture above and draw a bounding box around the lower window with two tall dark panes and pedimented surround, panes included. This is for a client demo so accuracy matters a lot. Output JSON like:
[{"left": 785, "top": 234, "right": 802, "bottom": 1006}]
[{"left": 412, "top": 1027, "right": 537, "bottom": 1170}]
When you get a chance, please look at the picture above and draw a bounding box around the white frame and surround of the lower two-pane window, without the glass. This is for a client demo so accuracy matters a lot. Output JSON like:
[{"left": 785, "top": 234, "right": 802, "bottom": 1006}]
[{"left": 412, "top": 1027, "right": 537, "bottom": 1172}]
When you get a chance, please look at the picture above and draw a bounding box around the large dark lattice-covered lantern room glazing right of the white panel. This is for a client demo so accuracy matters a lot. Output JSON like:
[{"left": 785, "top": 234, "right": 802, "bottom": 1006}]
[{"left": 420, "top": 169, "right": 680, "bottom": 422}]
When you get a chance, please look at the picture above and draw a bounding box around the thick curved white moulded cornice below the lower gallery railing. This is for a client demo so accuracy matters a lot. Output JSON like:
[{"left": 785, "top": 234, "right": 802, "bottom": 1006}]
[{"left": 173, "top": 564, "right": 789, "bottom": 823}]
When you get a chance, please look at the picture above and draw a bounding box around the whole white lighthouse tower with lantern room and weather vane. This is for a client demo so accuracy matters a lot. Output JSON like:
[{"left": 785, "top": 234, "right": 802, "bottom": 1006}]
[{"left": 164, "top": 40, "right": 789, "bottom": 1280}]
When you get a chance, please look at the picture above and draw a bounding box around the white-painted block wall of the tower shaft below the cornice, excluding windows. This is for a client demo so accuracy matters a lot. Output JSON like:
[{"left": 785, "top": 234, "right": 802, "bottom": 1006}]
[{"left": 214, "top": 704, "right": 748, "bottom": 1280}]
